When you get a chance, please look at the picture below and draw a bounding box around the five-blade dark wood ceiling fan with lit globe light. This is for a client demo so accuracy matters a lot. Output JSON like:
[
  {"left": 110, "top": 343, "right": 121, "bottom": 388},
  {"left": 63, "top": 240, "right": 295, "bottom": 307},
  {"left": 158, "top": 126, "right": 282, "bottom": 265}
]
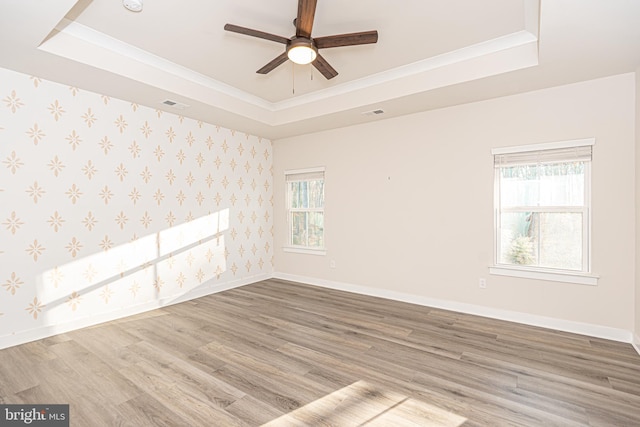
[{"left": 224, "top": 0, "right": 378, "bottom": 79}]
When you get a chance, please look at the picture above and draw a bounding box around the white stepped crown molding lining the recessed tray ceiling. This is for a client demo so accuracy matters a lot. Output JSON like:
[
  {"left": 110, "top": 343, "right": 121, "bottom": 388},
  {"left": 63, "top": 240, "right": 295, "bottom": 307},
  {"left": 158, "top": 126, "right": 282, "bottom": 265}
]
[{"left": 39, "top": 8, "right": 538, "bottom": 126}]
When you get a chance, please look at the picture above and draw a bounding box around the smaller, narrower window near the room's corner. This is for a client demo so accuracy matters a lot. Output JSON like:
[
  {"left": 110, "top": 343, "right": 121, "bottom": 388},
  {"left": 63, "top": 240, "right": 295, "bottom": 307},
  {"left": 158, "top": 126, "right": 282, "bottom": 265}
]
[{"left": 285, "top": 168, "right": 324, "bottom": 254}]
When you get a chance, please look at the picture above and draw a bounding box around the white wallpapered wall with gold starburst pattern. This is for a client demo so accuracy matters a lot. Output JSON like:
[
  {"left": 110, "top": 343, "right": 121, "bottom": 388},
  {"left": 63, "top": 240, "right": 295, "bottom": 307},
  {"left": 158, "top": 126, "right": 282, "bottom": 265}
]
[{"left": 0, "top": 69, "right": 273, "bottom": 347}]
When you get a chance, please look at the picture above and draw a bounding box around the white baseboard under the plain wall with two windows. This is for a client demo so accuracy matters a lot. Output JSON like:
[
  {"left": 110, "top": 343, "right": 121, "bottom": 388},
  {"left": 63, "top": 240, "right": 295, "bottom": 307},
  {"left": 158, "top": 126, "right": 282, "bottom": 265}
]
[{"left": 273, "top": 272, "right": 640, "bottom": 346}]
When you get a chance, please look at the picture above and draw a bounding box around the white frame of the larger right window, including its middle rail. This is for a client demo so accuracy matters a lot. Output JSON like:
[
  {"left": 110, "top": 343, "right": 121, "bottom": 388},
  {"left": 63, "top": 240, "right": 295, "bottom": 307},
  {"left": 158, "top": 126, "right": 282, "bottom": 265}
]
[{"left": 489, "top": 138, "right": 598, "bottom": 285}]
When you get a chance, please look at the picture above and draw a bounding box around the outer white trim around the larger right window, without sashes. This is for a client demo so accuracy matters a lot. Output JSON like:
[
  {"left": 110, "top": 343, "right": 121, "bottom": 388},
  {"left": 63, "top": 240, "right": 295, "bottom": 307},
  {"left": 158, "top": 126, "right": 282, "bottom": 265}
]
[{"left": 489, "top": 138, "right": 599, "bottom": 286}]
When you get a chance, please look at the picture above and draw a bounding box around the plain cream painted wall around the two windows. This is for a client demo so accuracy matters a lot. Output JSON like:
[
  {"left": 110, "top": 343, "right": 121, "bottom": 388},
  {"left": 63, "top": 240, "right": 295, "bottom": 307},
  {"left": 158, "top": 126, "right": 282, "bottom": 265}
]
[{"left": 274, "top": 73, "right": 640, "bottom": 334}]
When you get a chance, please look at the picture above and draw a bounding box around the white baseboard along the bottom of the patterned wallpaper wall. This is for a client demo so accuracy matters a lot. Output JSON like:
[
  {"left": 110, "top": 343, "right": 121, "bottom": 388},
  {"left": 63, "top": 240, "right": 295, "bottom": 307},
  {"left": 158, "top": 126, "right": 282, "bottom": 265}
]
[{"left": 0, "top": 274, "right": 272, "bottom": 350}]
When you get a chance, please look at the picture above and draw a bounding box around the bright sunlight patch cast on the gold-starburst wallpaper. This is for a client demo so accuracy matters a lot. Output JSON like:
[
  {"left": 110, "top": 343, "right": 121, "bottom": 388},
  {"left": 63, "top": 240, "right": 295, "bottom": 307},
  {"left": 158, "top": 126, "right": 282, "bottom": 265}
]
[{"left": 31, "top": 209, "right": 229, "bottom": 332}]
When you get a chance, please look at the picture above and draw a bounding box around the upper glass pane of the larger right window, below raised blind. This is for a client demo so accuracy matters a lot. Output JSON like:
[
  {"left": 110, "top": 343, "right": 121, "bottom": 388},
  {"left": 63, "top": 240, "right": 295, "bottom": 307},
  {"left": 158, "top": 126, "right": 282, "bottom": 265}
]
[{"left": 500, "top": 162, "right": 584, "bottom": 207}]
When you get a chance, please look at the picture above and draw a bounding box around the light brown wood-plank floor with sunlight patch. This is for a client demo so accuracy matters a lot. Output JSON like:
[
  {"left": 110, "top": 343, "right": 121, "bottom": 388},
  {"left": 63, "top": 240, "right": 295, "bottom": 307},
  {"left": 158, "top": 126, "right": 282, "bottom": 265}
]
[{"left": 0, "top": 280, "right": 640, "bottom": 427}]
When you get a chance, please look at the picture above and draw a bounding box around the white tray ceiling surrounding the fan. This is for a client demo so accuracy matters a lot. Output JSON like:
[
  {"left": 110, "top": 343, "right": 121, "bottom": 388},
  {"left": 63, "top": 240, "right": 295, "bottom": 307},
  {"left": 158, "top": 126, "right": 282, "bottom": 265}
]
[{"left": 0, "top": 0, "right": 640, "bottom": 139}]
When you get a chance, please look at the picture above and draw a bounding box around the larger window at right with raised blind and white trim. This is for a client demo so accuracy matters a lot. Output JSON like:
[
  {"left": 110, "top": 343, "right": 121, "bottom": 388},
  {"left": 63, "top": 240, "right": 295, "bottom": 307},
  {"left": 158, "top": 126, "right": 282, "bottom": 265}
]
[{"left": 491, "top": 140, "right": 596, "bottom": 284}]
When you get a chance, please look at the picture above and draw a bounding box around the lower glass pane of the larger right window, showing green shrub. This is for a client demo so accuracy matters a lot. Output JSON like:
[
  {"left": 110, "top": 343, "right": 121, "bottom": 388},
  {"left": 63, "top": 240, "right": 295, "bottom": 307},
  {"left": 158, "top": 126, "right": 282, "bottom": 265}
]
[{"left": 499, "top": 212, "right": 583, "bottom": 271}]
